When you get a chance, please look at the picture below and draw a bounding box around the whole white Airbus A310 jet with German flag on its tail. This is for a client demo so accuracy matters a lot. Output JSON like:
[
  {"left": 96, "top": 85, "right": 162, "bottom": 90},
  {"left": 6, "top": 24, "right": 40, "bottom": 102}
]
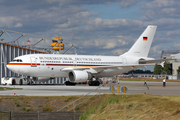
[{"left": 7, "top": 25, "right": 165, "bottom": 86}]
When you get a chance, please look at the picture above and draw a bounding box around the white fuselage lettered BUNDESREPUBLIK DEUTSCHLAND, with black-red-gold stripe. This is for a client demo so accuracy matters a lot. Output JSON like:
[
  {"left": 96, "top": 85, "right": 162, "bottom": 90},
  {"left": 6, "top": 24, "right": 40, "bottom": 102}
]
[{"left": 7, "top": 54, "right": 139, "bottom": 77}]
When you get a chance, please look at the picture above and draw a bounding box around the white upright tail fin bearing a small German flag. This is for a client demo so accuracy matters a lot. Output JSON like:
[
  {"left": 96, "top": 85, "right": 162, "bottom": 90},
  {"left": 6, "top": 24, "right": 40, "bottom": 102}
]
[{"left": 123, "top": 25, "right": 157, "bottom": 57}]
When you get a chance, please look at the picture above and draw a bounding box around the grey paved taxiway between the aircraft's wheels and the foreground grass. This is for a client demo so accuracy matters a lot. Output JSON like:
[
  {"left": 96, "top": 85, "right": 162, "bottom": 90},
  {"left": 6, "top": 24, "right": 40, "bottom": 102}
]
[{"left": 0, "top": 81, "right": 180, "bottom": 96}]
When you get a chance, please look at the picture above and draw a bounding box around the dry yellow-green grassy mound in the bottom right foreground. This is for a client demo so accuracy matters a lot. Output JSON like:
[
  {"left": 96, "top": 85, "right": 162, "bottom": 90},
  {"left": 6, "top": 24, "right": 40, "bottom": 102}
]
[{"left": 80, "top": 95, "right": 180, "bottom": 120}]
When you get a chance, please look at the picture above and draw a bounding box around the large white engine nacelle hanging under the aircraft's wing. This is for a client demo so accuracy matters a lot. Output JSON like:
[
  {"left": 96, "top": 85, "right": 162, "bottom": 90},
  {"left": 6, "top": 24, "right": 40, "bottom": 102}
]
[{"left": 68, "top": 70, "right": 93, "bottom": 82}]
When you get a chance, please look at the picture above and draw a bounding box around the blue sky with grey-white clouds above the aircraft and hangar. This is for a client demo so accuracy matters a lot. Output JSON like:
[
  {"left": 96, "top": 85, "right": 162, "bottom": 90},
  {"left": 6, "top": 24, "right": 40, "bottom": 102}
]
[{"left": 0, "top": 0, "right": 180, "bottom": 70}]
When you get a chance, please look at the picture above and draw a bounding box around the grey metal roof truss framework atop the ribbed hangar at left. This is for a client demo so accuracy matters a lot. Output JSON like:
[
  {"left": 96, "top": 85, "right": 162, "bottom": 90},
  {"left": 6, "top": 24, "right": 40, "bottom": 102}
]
[{"left": 0, "top": 28, "right": 77, "bottom": 54}]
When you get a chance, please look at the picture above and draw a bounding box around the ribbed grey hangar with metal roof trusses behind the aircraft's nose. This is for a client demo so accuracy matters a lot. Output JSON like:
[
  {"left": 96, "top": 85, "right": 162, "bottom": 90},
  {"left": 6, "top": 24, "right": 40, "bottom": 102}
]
[{"left": 0, "top": 29, "right": 77, "bottom": 84}]
